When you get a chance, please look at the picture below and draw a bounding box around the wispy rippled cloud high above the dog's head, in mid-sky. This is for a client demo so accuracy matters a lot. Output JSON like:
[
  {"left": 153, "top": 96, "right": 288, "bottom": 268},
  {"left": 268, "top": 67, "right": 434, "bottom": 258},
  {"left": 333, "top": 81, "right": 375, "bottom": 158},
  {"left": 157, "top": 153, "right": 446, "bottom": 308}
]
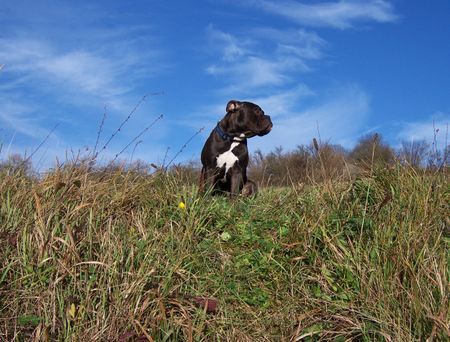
[{"left": 206, "top": 26, "right": 326, "bottom": 95}]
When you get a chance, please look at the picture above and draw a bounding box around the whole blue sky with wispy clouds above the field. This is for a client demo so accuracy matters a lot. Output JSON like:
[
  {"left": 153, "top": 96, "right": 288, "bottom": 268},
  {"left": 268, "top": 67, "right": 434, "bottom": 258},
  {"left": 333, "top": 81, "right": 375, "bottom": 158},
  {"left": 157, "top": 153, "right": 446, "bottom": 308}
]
[{"left": 0, "top": 0, "right": 450, "bottom": 169}]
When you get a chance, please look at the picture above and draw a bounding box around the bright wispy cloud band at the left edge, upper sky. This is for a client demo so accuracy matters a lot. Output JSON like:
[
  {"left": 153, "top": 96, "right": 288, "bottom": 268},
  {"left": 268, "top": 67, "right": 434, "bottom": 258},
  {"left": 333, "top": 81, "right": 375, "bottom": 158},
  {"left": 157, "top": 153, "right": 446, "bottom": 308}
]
[{"left": 0, "top": 38, "right": 161, "bottom": 106}]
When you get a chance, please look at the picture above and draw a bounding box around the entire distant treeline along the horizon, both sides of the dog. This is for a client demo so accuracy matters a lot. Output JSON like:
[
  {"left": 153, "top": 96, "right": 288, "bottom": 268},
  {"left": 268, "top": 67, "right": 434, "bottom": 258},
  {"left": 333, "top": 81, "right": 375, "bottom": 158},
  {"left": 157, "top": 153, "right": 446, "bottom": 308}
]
[{"left": 0, "top": 133, "right": 450, "bottom": 186}]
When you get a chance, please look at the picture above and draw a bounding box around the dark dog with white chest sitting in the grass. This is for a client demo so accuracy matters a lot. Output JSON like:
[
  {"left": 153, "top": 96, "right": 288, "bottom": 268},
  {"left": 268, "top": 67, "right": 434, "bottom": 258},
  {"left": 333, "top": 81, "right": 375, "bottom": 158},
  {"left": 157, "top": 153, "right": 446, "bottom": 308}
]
[{"left": 199, "top": 100, "right": 273, "bottom": 195}]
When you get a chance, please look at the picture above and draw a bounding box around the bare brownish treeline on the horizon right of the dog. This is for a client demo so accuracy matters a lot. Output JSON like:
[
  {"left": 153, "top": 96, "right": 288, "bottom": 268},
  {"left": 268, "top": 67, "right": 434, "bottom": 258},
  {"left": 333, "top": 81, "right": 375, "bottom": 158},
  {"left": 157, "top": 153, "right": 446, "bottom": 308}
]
[{"left": 250, "top": 133, "right": 449, "bottom": 186}]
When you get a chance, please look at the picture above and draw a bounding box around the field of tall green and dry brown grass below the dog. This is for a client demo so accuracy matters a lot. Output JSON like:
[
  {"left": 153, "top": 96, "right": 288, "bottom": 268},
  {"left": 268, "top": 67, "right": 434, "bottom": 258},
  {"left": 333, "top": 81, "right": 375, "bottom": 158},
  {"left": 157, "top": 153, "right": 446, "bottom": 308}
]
[{"left": 0, "top": 166, "right": 450, "bottom": 341}]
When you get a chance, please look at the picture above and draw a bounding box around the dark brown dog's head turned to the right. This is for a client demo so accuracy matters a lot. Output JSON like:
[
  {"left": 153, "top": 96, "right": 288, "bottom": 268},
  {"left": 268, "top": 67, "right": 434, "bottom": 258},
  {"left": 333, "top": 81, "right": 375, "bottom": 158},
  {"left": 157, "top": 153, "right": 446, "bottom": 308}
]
[{"left": 223, "top": 100, "right": 273, "bottom": 138}]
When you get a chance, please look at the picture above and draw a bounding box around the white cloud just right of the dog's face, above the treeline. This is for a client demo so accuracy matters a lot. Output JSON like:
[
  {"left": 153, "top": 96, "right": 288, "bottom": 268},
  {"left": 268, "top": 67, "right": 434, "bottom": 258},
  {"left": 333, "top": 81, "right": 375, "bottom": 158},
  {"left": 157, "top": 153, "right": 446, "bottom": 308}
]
[{"left": 249, "top": 84, "right": 370, "bottom": 152}]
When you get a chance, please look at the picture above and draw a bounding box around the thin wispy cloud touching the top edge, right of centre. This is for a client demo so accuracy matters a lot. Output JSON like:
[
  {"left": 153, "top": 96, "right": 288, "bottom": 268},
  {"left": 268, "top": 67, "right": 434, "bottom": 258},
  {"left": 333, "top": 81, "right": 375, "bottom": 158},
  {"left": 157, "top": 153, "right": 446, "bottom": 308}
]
[{"left": 247, "top": 0, "right": 398, "bottom": 29}]
